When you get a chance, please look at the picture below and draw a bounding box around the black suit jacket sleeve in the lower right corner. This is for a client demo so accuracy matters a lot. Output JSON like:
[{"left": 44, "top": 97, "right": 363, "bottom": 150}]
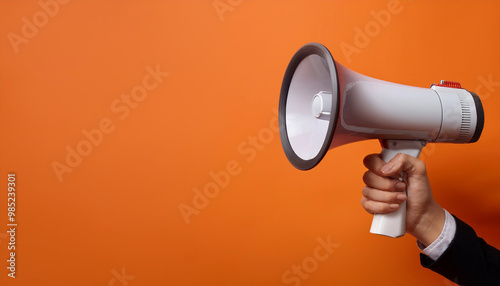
[{"left": 420, "top": 216, "right": 500, "bottom": 286}]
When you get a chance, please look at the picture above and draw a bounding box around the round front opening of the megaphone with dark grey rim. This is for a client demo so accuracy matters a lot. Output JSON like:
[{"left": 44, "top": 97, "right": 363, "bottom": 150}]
[{"left": 279, "top": 43, "right": 340, "bottom": 170}]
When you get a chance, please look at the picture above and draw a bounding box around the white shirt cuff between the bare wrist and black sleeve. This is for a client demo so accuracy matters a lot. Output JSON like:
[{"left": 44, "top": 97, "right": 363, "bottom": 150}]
[{"left": 417, "top": 210, "right": 457, "bottom": 261}]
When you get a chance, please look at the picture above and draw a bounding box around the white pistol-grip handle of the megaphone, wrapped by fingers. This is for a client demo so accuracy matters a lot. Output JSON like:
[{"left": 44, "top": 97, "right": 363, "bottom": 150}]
[{"left": 370, "top": 140, "right": 426, "bottom": 237}]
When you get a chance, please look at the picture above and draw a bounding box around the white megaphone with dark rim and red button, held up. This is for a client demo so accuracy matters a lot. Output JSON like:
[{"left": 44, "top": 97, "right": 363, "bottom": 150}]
[{"left": 279, "top": 43, "right": 484, "bottom": 237}]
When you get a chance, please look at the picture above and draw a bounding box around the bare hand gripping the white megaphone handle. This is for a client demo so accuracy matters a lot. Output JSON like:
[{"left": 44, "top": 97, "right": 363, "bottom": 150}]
[{"left": 361, "top": 153, "right": 445, "bottom": 246}]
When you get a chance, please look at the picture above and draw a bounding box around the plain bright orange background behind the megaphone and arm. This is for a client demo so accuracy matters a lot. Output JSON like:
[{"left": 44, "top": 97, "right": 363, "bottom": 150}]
[{"left": 0, "top": 0, "right": 500, "bottom": 286}]
